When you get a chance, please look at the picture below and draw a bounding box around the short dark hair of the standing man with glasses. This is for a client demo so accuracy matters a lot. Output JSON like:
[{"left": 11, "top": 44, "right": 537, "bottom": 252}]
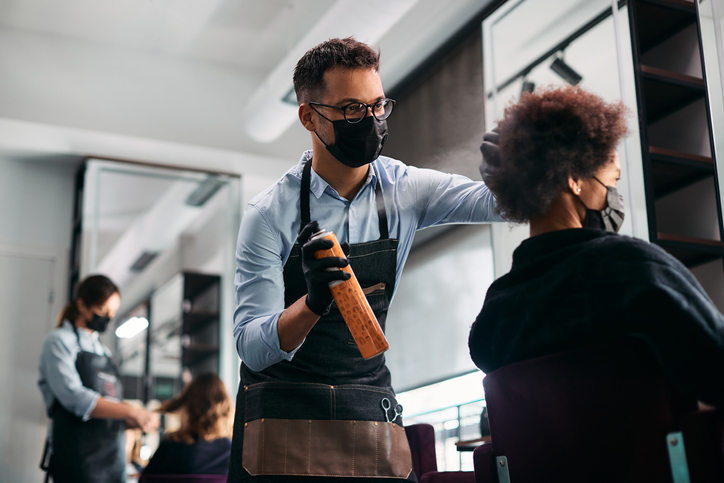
[{"left": 294, "top": 37, "right": 380, "bottom": 104}]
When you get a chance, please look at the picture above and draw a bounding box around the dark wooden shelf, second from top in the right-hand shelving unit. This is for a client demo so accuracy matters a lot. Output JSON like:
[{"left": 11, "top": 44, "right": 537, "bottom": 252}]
[{"left": 641, "top": 65, "right": 706, "bottom": 124}]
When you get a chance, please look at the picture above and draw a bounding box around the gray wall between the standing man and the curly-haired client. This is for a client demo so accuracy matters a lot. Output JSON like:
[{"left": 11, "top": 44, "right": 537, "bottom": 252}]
[{"left": 383, "top": 32, "right": 493, "bottom": 391}]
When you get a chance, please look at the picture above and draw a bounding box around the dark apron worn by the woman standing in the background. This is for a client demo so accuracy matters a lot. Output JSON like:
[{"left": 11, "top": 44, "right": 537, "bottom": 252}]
[{"left": 46, "top": 326, "right": 126, "bottom": 483}]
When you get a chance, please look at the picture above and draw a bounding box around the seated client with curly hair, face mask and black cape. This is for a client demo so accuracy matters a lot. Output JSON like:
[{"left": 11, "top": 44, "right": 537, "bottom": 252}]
[{"left": 469, "top": 87, "right": 724, "bottom": 406}]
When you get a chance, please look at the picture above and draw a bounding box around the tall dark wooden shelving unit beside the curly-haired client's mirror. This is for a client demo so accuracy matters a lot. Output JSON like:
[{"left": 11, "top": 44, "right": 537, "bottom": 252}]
[{"left": 629, "top": 0, "right": 724, "bottom": 278}]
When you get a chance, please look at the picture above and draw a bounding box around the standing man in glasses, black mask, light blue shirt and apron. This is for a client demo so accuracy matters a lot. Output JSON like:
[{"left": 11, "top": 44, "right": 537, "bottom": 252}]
[{"left": 229, "top": 38, "right": 501, "bottom": 482}]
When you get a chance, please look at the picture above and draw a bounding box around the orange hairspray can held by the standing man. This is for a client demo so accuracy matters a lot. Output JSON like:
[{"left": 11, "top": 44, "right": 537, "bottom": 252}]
[{"left": 311, "top": 230, "right": 390, "bottom": 359}]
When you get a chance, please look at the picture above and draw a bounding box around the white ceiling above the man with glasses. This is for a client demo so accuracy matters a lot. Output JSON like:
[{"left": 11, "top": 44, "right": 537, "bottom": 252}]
[{"left": 0, "top": 0, "right": 491, "bottom": 170}]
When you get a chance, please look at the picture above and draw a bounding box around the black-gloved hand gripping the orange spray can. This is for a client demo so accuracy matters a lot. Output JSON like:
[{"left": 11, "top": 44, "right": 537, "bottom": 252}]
[{"left": 297, "top": 221, "right": 350, "bottom": 316}]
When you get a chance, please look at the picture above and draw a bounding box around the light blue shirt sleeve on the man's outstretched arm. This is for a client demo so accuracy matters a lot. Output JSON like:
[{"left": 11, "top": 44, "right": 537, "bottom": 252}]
[{"left": 407, "top": 166, "right": 505, "bottom": 229}]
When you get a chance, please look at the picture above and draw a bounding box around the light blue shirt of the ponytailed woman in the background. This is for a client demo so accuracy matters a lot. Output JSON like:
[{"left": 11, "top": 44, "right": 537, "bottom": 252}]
[{"left": 38, "top": 320, "right": 110, "bottom": 421}]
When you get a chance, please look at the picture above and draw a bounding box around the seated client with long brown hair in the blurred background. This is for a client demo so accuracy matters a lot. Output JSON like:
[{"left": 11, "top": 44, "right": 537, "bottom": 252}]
[{"left": 143, "top": 373, "right": 233, "bottom": 475}]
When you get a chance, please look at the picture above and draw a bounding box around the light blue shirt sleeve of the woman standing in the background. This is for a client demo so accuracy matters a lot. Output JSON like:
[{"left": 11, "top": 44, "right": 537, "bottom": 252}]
[{"left": 40, "top": 333, "right": 101, "bottom": 421}]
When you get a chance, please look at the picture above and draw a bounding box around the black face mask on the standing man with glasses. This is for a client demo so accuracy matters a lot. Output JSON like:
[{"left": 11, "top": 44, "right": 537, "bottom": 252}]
[{"left": 314, "top": 116, "right": 387, "bottom": 168}]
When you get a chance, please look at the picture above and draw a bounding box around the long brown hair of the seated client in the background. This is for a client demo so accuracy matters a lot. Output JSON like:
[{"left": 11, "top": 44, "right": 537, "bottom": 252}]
[{"left": 160, "top": 372, "right": 234, "bottom": 444}]
